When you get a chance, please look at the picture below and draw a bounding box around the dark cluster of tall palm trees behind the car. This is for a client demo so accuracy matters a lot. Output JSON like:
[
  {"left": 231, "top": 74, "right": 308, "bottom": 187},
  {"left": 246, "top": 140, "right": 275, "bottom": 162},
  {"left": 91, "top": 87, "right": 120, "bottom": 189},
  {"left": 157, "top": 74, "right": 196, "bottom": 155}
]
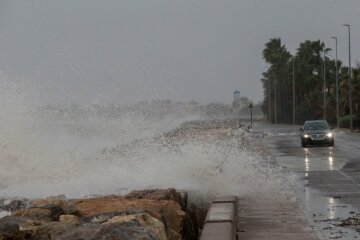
[{"left": 261, "top": 38, "right": 360, "bottom": 126}]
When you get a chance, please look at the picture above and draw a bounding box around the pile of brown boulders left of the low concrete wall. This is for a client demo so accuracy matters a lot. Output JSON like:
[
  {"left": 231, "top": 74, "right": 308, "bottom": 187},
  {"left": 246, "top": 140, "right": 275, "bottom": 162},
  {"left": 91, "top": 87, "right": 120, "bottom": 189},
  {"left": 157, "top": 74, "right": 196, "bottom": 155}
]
[{"left": 0, "top": 189, "right": 206, "bottom": 240}]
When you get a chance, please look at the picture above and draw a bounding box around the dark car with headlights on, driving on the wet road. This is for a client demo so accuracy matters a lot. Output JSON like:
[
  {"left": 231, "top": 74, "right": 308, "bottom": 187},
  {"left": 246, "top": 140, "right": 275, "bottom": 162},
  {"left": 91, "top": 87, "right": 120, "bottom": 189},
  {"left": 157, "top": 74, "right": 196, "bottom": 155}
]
[{"left": 300, "top": 120, "right": 334, "bottom": 147}]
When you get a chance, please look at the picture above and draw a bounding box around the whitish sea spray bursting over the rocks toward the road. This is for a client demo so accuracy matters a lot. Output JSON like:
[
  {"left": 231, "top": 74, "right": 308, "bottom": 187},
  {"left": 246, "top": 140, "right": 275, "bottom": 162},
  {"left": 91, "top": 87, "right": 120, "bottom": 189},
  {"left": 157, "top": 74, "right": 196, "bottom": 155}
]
[{"left": 0, "top": 75, "right": 286, "bottom": 202}]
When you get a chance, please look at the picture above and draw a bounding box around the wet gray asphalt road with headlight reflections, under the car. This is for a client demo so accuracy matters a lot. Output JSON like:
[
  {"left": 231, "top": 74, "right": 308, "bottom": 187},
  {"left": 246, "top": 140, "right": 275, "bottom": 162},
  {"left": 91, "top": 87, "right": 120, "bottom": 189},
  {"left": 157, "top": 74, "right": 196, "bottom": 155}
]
[{"left": 255, "top": 124, "right": 360, "bottom": 239}]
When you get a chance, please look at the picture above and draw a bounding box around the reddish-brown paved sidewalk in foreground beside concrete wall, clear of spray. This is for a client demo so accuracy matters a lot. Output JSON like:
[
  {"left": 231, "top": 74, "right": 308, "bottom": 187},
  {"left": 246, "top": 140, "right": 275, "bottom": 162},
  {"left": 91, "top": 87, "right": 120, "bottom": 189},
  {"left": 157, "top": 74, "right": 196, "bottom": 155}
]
[{"left": 238, "top": 191, "right": 318, "bottom": 240}]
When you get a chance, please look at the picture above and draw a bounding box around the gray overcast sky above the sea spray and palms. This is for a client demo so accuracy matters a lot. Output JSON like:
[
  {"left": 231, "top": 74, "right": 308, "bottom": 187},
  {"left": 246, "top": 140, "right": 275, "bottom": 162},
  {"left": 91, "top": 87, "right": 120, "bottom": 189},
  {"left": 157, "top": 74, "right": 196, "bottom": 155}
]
[{"left": 0, "top": 0, "right": 360, "bottom": 103}]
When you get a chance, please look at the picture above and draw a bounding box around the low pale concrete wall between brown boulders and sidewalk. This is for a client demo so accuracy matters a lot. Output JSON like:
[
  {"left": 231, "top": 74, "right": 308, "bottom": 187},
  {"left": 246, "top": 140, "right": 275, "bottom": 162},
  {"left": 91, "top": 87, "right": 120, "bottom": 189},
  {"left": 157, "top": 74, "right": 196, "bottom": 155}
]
[{"left": 200, "top": 196, "right": 238, "bottom": 240}]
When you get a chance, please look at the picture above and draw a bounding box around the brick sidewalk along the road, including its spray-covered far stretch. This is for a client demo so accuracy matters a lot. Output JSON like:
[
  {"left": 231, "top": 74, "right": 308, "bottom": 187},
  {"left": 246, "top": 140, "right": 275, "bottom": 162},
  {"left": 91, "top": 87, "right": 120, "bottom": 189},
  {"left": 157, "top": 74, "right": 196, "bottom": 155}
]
[{"left": 238, "top": 124, "right": 322, "bottom": 240}]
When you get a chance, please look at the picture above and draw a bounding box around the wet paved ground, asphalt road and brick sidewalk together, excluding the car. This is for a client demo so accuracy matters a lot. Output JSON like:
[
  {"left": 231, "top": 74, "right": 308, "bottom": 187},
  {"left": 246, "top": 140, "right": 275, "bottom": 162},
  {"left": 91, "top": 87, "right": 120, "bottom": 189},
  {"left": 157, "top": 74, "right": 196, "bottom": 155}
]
[{"left": 239, "top": 123, "right": 360, "bottom": 239}]
